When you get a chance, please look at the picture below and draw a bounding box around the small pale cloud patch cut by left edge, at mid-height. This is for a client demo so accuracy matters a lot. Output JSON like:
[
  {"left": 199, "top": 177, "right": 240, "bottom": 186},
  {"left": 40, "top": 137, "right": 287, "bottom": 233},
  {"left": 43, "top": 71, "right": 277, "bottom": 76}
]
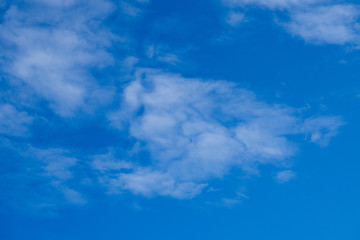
[{"left": 0, "top": 104, "right": 33, "bottom": 136}]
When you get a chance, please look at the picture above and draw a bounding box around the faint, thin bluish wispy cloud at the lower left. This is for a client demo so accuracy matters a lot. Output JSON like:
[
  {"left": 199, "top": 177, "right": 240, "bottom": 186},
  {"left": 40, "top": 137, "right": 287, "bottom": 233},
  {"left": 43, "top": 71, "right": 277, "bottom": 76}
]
[{"left": 0, "top": 142, "right": 86, "bottom": 212}]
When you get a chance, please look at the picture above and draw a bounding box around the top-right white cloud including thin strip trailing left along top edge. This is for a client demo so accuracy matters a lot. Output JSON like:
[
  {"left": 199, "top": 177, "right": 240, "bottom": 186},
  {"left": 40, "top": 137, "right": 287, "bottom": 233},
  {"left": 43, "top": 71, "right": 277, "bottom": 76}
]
[{"left": 223, "top": 0, "right": 360, "bottom": 47}]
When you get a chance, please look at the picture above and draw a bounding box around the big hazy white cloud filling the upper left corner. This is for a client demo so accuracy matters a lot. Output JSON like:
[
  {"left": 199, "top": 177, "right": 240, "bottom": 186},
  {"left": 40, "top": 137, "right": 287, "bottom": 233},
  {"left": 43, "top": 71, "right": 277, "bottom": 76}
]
[{"left": 0, "top": 0, "right": 114, "bottom": 116}]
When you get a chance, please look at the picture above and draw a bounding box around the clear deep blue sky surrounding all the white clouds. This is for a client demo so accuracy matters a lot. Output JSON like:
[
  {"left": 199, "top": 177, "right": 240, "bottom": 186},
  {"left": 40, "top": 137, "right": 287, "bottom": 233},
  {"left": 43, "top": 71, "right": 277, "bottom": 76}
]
[{"left": 0, "top": 0, "right": 360, "bottom": 240}]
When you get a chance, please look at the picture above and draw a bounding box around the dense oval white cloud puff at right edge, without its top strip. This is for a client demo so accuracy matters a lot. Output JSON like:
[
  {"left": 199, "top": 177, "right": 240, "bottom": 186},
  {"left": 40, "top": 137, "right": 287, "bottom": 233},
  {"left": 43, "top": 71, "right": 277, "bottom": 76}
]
[{"left": 284, "top": 4, "right": 360, "bottom": 45}]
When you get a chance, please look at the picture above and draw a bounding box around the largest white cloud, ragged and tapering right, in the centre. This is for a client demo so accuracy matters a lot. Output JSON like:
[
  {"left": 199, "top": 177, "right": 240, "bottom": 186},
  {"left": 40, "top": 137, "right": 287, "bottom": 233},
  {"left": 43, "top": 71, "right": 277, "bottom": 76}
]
[{"left": 107, "top": 70, "right": 343, "bottom": 198}]
